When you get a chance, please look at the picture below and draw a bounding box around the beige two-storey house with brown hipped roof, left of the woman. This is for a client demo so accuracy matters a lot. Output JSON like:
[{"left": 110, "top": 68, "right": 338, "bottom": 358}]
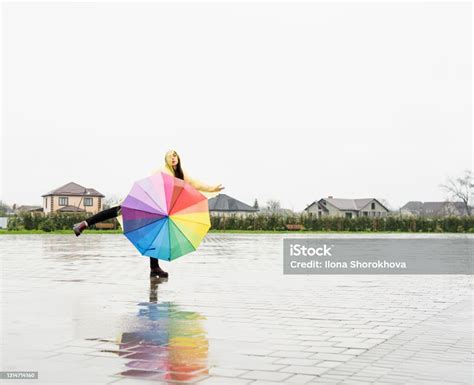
[{"left": 42, "top": 182, "right": 104, "bottom": 214}]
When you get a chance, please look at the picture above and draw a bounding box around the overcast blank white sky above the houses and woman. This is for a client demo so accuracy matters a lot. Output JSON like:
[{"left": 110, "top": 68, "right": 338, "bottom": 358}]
[{"left": 1, "top": 2, "right": 472, "bottom": 210}]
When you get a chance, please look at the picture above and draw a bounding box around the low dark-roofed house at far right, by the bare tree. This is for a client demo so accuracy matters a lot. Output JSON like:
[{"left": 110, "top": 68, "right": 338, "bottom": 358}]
[{"left": 400, "top": 201, "right": 473, "bottom": 217}]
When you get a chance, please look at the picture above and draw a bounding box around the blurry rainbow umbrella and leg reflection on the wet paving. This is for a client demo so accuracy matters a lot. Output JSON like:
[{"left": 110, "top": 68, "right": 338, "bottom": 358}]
[{"left": 114, "top": 279, "right": 208, "bottom": 381}]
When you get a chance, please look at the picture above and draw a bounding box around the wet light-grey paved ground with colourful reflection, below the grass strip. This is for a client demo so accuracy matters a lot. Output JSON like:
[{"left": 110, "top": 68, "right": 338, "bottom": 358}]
[{"left": 0, "top": 234, "right": 473, "bottom": 385}]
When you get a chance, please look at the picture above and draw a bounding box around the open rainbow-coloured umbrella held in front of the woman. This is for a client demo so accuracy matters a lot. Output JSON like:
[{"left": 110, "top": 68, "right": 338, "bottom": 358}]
[{"left": 121, "top": 172, "right": 211, "bottom": 261}]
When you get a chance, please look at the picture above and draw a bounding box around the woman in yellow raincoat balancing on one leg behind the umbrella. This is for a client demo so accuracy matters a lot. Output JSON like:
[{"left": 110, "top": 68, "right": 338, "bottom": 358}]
[{"left": 73, "top": 150, "right": 224, "bottom": 278}]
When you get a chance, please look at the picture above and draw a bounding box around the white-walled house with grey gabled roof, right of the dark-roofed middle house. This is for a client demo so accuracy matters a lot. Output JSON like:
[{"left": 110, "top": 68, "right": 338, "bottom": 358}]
[{"left": 304, "top": 196, "right": 390, "bottom": 218}]
